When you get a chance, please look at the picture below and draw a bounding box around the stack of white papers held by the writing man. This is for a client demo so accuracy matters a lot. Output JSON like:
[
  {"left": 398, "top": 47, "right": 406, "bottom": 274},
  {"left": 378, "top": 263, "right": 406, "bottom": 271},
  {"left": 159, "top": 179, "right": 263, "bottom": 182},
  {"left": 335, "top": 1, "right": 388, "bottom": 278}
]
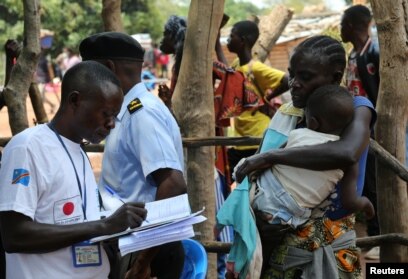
[{"left": 91, "top": 194, "right": 207, "bottom": 256}]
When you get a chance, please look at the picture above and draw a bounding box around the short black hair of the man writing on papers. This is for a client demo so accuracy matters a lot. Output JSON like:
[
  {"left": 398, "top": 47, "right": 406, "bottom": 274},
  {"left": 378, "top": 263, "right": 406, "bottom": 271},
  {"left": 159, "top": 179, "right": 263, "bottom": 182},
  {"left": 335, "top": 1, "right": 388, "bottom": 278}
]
[{"left": 61, "top": 60, "right": 120, "bottom": 105}]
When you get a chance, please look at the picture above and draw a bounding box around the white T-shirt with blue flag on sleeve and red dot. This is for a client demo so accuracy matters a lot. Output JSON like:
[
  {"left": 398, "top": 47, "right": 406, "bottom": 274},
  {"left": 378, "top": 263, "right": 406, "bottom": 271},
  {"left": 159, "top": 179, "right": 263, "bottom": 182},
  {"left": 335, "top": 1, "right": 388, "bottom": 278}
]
[{"left": 0, "top": 125, "right": 109, "bottom": 279}]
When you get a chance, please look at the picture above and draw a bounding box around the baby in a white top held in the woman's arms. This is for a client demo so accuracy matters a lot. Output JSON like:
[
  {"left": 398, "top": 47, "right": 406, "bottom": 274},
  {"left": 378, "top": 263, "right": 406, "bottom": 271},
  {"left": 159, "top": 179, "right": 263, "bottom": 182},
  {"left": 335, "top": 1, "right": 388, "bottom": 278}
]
[{"left": 253, "top": 85, "right": 374, "bottom": 228}]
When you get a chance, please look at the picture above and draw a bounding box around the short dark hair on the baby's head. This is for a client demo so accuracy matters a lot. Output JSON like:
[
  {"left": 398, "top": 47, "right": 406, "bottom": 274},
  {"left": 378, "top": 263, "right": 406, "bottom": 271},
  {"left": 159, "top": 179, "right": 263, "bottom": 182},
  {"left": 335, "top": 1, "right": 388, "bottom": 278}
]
[{"left": 306, "top": 84, "right": 354, "bottom": 134}]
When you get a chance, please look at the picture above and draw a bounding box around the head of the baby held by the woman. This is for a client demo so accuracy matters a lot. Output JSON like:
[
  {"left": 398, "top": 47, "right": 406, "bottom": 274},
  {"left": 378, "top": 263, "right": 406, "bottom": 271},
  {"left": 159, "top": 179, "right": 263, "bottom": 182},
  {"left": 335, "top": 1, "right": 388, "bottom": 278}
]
[{"left": 305, "top": 85, "right": 354, "bottom": 135}]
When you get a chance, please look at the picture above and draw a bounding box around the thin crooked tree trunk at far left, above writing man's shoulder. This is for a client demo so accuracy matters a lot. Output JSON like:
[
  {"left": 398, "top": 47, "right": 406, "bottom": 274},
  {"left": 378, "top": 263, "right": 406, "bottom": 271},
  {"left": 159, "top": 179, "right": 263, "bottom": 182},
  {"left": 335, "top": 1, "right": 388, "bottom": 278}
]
[{"left": 3, "top": 0, "right": 40, "bottom": 135}]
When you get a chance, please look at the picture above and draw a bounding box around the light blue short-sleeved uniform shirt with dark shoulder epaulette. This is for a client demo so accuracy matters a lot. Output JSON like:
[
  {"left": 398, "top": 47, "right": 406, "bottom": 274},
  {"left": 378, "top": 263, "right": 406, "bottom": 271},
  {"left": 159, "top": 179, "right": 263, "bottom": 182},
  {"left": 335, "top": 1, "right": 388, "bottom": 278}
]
[{"left": 99, "top": 83, "right": 184, "bottom": 209}]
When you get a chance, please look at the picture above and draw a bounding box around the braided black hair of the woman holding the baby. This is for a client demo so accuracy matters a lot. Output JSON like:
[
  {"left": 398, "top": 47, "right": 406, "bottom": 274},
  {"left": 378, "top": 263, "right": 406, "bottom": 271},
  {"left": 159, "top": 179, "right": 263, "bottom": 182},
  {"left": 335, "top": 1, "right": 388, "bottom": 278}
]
[{"left": 293, "top": 35, "right": 346, "bottom": 72}]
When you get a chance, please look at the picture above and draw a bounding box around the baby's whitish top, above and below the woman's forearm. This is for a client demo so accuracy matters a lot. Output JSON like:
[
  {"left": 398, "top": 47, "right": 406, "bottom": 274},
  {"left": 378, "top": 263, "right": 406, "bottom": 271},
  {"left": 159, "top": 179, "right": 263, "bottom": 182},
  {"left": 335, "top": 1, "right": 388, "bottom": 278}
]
[{"left": 265, "top": 128, "right": 343, "bottom": 208}]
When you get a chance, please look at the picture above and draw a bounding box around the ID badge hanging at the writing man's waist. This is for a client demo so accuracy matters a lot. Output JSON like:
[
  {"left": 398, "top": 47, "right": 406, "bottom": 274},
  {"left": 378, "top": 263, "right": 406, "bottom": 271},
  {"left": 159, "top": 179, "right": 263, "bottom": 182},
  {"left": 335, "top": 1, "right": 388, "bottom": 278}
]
[{"left": 71, "top": 241, "right": 102, "bottom": 268}]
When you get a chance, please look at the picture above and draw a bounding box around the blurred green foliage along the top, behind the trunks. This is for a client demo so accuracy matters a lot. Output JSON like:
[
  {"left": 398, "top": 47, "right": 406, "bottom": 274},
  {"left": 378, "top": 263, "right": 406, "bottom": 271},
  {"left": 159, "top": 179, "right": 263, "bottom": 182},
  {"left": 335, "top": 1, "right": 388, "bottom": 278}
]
[{"left": 0, "top": 0, "right": 263, "bottom": 85}]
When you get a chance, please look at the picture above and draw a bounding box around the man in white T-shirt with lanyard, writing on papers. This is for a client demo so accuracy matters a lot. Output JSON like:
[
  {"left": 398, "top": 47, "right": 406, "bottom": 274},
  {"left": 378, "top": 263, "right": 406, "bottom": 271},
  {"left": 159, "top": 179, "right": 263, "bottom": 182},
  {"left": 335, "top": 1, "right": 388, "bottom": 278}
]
[{"left": 0, "top": 61, "right": 146, "bottom": 279}]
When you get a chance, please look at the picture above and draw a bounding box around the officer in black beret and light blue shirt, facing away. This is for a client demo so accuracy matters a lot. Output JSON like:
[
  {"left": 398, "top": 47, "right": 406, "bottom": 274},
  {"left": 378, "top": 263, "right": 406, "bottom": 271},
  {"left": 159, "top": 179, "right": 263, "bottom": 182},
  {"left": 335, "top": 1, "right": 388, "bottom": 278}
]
[{"left": 79, "top": 32, "right": 187, "bottom": 279}]
